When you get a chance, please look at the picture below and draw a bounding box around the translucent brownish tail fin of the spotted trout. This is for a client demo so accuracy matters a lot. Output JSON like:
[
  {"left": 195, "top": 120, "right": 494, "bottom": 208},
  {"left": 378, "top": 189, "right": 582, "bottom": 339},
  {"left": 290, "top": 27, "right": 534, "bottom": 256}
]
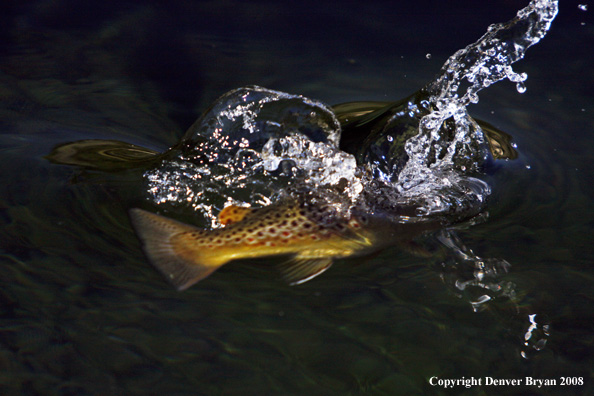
[{"left": 130, "top": 208, "right": 221, "bottom": 290}]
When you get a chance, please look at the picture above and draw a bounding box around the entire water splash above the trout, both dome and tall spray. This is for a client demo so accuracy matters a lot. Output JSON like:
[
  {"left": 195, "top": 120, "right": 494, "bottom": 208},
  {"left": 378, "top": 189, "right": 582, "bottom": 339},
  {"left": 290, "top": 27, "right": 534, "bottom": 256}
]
[{"left": 145, "top": 0, "right": 558, "bottom": 230}]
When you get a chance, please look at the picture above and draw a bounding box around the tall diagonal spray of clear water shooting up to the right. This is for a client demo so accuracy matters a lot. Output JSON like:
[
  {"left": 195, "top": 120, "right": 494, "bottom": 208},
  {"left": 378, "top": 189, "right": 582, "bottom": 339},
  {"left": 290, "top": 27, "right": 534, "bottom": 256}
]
[{"left": 396, "top": 0, "right": 558, "bottom": 213}]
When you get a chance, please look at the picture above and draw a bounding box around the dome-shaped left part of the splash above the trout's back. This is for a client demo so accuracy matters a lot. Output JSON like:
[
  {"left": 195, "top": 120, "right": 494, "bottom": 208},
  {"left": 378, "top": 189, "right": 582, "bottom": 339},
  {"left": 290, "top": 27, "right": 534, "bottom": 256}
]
[{"left": 144, "top": 86, "right": 362, "bottom": 226}]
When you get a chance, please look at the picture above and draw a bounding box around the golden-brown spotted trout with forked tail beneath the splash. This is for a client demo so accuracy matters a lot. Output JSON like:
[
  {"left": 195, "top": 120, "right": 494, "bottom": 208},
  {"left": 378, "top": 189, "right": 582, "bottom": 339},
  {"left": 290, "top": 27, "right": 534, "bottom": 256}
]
[{"left": 130, "top": 200, "right": 404, "bottom": 290}]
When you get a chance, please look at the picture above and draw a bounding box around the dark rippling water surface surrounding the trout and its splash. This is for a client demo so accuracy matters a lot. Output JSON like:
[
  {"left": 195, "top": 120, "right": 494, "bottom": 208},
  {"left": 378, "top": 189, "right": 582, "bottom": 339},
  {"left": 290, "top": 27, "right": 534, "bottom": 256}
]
[{"left": 0, "top": 1, "right": 594, "bottom": 395}]
